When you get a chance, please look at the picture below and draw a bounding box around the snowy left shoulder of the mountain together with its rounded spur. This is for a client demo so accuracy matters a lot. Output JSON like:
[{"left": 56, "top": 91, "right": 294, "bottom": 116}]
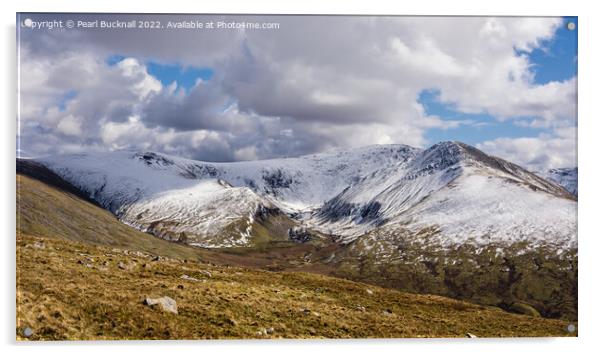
[{"left": 39, "top": 152, "right": 273, "bottom": 247}]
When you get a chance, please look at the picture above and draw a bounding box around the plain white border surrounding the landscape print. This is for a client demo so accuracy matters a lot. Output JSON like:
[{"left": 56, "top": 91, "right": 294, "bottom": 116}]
[{"left": 0, "top": 0, "right": 602, "bottom": 354}]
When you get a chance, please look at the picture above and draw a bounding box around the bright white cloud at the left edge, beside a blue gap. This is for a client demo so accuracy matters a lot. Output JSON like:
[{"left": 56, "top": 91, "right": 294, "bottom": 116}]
[{"left": 20, "top": 46, "right": 162, "bottom": 146}]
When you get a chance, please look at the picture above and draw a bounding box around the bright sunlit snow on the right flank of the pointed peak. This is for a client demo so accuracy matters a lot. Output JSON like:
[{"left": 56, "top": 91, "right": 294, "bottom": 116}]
[{"left": 386, "top": 168, "right": 577, "bottom": 247}]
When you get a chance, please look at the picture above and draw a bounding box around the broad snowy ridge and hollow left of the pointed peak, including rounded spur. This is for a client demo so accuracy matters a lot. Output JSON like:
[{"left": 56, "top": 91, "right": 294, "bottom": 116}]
[{"left": 38, "top": 145, "right": 419, "bottom": 247}]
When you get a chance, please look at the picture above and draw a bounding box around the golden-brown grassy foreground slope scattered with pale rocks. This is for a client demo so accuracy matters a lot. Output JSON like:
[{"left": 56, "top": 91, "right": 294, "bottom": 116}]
[{"left": 17, "top": 235, "right": 574, "bottom": 340}]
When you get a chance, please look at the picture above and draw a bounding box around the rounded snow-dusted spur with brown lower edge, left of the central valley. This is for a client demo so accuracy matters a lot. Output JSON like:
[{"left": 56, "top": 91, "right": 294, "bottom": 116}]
[{"left": 122, "top": 179, "right": 269, "bottom": 247}]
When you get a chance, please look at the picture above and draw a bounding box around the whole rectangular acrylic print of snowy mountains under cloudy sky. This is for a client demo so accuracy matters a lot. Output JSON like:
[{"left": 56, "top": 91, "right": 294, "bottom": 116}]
[{"left": 16, "top": 13, "right": 578, "bottom": 341}]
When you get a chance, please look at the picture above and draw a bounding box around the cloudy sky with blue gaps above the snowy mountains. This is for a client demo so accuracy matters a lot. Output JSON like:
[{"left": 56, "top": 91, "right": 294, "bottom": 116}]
[{"left": 17, "top": 14, "right": 577, "bottom": 170}]
